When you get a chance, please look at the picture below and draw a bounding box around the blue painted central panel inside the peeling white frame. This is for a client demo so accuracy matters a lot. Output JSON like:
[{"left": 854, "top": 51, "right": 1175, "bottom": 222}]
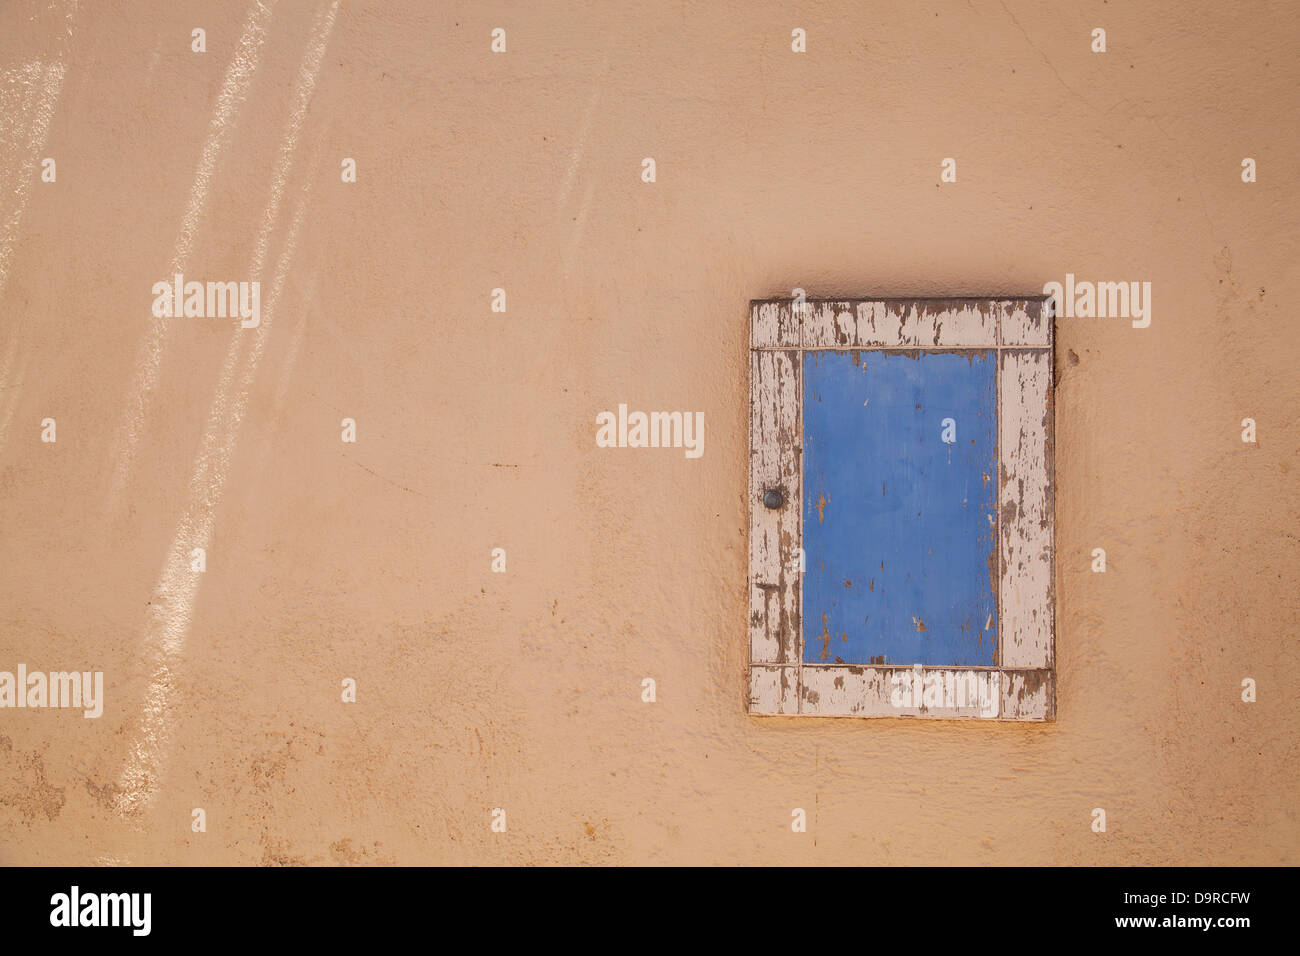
[{"left": 803, "top": 350, "right": 997, "bottom": 666}]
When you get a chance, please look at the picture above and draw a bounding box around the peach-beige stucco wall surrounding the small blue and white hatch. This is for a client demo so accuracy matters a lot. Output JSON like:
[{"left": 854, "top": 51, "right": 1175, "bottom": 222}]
[{"left": 0, "top": 0, "right": 1300, "bottom": 864}]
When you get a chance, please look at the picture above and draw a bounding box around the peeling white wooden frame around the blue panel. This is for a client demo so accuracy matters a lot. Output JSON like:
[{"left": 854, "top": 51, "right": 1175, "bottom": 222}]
[{"left": 749, "top": 297, "right": 1056, "bottom": 721}]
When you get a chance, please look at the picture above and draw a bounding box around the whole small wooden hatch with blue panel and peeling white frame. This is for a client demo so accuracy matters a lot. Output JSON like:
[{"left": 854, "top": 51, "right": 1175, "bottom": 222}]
[{"left": 749, "top": 298, "right": 1056, "bottom": 721}]
